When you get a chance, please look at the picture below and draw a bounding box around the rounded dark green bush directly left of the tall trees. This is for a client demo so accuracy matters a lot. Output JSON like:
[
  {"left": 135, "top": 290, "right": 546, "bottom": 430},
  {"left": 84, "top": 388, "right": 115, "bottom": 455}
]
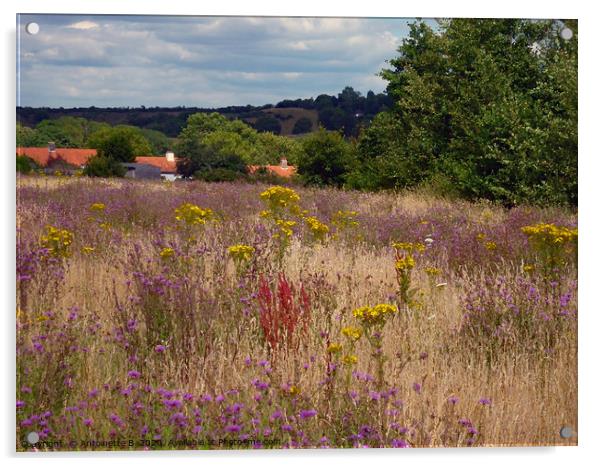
[{"left": 297, "top": 128, "right": 354, "bottom": 186}]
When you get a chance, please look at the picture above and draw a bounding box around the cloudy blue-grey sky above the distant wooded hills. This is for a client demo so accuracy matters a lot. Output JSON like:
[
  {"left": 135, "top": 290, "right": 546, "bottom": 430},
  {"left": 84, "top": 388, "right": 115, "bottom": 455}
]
[{"left": 17, "top": 14, "right": 426, "bottom": 108}]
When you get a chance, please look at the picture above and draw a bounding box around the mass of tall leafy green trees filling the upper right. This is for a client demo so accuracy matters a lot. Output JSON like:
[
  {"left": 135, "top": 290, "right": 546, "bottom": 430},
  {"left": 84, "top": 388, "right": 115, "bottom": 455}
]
[{"left": 358, "top": 19, "right": 577, "bottom": 205}]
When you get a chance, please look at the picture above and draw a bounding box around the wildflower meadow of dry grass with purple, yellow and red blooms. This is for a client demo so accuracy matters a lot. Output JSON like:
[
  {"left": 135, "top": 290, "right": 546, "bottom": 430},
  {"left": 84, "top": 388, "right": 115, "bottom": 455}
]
[{"left": 16, "top": 176, "right": 577, "bottom": 451}]
